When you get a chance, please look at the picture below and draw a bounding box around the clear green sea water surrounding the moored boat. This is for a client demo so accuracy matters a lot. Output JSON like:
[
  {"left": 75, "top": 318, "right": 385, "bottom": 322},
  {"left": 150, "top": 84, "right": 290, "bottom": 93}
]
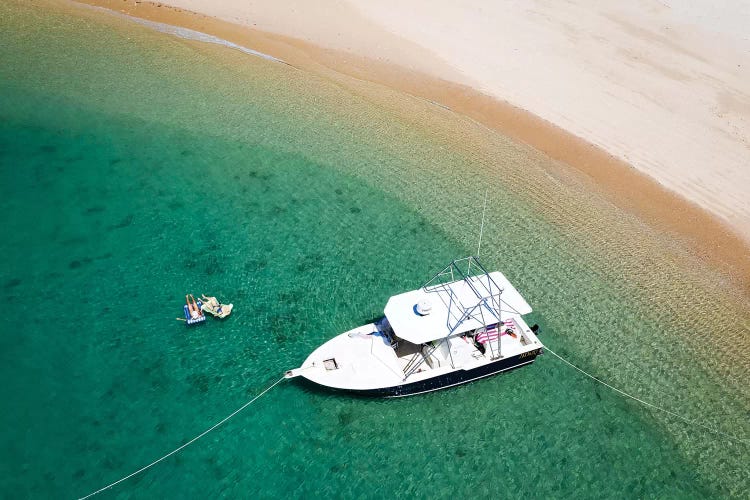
[{"left": 0, "top": 2, "right": 750, "bottom": 498}]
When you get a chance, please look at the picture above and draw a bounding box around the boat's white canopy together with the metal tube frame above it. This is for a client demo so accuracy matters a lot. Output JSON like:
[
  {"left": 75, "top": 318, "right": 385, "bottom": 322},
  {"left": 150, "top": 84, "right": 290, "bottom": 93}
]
[{"left": 385, "top": 268, "right": 531, "bottom": 344}]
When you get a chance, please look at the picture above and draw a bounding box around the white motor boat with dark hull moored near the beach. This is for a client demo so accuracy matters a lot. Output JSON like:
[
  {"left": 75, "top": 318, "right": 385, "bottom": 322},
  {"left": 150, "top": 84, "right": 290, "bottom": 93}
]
[{"left": 286, "top": 257, "right": 544, "bottom": 397}]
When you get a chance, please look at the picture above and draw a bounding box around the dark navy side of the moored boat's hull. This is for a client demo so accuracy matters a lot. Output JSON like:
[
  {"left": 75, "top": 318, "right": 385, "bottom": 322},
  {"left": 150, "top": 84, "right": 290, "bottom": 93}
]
[{"left": 306, "top": 348, "right": 542, "bottom": 398}]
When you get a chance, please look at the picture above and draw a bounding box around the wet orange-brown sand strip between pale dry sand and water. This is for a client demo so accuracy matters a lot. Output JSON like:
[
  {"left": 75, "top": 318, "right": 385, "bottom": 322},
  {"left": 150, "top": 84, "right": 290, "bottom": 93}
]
[{"left": 73, "top": 0, "right": 750, "bottom": 294}]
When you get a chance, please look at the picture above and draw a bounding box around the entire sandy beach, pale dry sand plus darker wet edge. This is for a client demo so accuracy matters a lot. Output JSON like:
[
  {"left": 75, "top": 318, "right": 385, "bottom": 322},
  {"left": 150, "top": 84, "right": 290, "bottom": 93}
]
[{"left": 78, "top": 0, "right": 750, "bottom": 288}]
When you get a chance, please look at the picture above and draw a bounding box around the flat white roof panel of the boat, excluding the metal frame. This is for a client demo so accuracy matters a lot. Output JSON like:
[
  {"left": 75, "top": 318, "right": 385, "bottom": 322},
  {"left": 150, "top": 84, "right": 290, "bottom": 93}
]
[{"left": 385, "top": 271, "right": 531, "bottom": 344}]
